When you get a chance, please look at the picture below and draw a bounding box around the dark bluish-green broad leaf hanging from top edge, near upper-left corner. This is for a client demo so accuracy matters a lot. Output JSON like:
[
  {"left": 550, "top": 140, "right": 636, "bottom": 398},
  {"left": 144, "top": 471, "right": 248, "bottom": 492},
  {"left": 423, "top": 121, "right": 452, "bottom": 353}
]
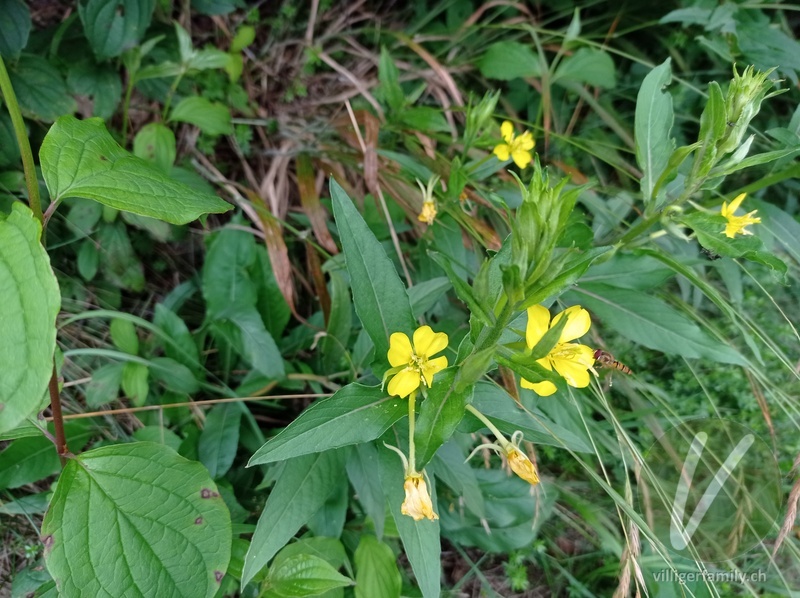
[{"left": 78, "top": 0, "right": 156, "bottom": 58}]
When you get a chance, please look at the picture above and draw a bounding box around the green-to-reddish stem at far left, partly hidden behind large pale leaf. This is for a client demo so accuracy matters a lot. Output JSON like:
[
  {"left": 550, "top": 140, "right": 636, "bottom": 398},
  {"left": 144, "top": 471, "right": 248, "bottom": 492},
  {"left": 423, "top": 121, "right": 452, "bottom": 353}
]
[{"left": 0, "top": 57, "right": 69, "bottom": 467}]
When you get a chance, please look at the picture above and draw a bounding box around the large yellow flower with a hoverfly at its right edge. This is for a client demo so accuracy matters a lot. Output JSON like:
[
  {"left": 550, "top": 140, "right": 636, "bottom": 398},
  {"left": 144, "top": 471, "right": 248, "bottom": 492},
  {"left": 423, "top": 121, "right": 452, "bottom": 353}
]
[{"left": 522, "top": 305, "right": 594, "bottom": 397}]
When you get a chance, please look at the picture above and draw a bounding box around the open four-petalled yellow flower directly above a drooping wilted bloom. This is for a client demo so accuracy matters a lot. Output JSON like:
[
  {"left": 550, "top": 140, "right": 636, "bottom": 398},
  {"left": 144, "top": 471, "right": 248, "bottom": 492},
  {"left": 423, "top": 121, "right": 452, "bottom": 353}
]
[{"left": 387, "top": 326, "right": 448, "bottom": 398}]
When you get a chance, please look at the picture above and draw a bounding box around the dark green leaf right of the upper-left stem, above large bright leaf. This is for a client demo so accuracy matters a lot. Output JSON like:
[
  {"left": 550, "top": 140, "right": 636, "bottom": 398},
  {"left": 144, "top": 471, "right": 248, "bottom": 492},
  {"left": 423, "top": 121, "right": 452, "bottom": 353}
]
[{"left": 8, "top": 54, "right": 78, "bottom": 122}]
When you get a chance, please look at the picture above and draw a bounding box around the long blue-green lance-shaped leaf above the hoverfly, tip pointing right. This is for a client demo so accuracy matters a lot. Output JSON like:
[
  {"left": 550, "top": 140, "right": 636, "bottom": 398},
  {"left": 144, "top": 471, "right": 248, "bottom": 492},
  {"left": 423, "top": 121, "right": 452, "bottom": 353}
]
[{"left": 568, "top": 284, "right": 747, "bottom": 365}]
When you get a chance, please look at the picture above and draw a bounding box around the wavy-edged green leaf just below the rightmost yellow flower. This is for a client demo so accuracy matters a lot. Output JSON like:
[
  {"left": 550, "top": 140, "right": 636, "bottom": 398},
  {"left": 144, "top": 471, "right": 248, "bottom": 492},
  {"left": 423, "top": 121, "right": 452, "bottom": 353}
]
[{"left": 681, "top": 212, "right": 788, "bottom": 284}]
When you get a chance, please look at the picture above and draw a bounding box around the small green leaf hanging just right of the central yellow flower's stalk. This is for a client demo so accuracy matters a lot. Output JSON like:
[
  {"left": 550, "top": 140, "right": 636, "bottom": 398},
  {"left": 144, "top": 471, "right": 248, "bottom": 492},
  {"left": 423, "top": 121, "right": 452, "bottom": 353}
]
[{"left": 414, "top": 367, "right": 474, "bottom": 469}]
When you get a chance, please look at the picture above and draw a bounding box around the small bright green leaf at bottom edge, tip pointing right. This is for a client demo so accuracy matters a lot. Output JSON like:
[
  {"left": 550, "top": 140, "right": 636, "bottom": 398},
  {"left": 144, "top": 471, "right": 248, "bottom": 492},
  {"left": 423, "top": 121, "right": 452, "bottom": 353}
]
[{"left": 267, "top": 554, "right": 353, "bottom": 598}]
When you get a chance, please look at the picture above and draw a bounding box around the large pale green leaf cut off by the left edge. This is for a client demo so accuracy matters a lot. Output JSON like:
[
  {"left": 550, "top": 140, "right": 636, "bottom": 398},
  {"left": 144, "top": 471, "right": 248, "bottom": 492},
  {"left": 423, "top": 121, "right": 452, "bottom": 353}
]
[{"left": 0, "top": 202, "right": 61, "bottom": 433}]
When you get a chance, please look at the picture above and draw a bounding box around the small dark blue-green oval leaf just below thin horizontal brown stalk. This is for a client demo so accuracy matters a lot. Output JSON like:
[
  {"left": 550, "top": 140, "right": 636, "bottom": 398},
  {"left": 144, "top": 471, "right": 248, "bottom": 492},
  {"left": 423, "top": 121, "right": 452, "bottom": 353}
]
[{"left": 197, "top": 403, "right": 242, "bottom": 479}]
